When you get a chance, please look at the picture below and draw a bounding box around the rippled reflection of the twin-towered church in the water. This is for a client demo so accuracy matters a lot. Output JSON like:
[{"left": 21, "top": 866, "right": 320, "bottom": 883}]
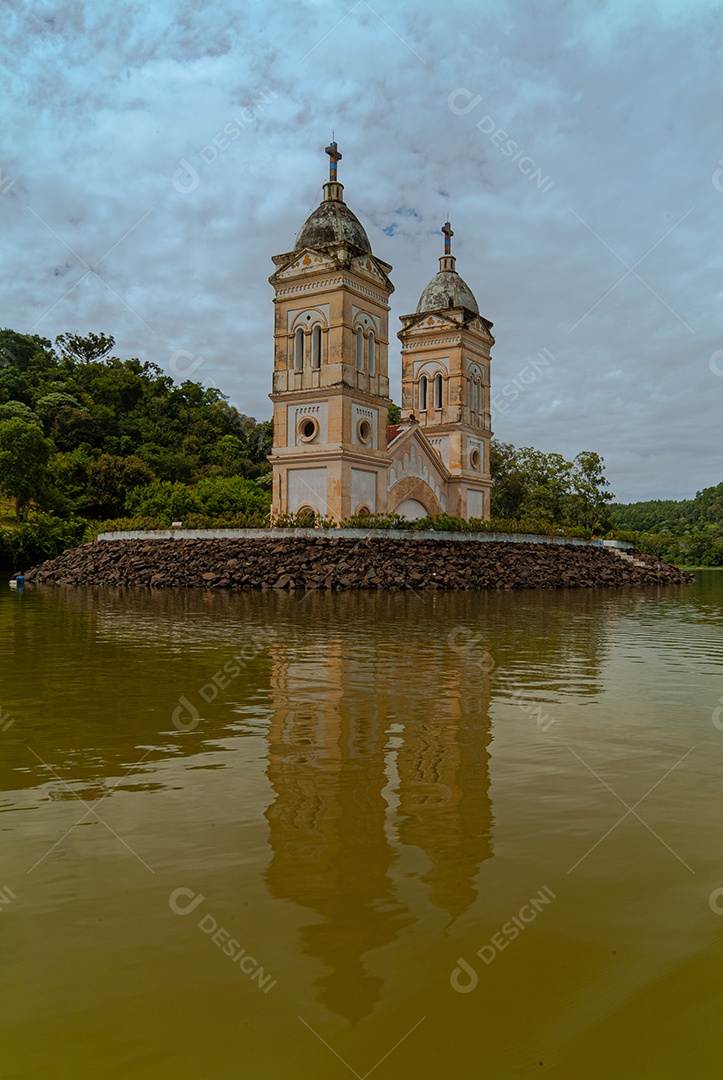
[{"left": 262, "top": 622, "right": 492, "bottom": 1023}]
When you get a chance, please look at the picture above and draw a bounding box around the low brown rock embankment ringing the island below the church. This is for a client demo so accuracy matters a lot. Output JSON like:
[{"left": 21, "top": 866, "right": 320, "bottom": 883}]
[{"left": 25, "top": 536, "right": 693, "bottom": 589}]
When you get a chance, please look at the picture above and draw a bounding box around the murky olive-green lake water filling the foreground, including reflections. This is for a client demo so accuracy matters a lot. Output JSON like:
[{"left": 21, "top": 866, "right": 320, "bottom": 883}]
[{"left": 0, "top": 571, "right": 723, "bottom": 1080}]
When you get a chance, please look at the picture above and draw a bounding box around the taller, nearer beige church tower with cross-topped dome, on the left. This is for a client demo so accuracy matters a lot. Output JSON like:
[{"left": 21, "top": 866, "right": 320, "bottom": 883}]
[{"left": 269, "top": 143, "right": 393, "bottom": 521}]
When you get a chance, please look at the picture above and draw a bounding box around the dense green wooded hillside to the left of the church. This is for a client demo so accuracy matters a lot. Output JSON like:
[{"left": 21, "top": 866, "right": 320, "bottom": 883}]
[{"left": 0, "top": 330, "right": 271, "bottom": 529}]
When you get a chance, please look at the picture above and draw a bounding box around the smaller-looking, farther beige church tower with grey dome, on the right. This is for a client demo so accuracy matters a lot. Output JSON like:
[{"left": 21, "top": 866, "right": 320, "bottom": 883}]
[{"left": 399, "top": 221, "right": 495, "bottom": 517}]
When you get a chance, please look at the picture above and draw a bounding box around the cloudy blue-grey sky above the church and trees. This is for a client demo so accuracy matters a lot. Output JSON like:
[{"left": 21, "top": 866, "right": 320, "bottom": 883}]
[{"left": 0, "top": 0, "right": 723, "bottom": 501}]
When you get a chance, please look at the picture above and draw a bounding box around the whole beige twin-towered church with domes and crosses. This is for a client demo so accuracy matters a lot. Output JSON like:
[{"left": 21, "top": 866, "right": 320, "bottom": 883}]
[{"left": 269, "top": 143, "right": 494, "bottom": 522}]
